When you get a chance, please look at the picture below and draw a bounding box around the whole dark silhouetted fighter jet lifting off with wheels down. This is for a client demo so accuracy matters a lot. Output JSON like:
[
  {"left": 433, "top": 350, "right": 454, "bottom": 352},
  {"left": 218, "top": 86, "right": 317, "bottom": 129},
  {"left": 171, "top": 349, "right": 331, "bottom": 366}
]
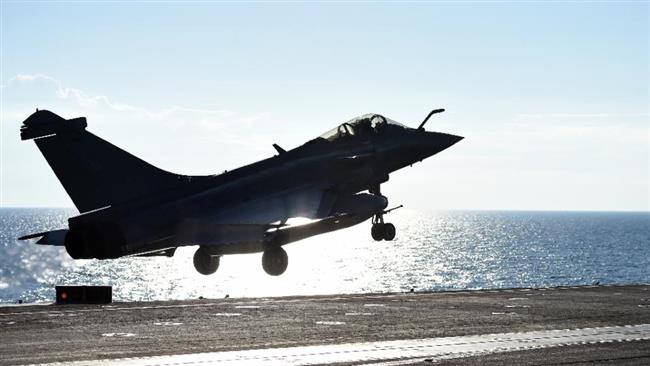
[{"left": 20, "top": 109, "right": 462, "bottom": 276}]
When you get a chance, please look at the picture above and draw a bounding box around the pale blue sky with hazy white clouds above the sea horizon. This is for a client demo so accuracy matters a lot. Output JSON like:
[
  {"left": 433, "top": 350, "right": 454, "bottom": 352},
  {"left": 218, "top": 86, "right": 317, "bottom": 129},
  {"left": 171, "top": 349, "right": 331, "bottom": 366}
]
[{"left": 0, "top": 1, "right": 650, "bottom": 210}]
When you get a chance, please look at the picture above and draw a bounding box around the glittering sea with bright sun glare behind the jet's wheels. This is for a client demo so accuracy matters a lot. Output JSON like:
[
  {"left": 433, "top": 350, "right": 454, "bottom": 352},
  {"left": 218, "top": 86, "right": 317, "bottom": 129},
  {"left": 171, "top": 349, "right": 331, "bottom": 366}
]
[{"left": 0, "top": 208, "right": 650, "bottom": 304}]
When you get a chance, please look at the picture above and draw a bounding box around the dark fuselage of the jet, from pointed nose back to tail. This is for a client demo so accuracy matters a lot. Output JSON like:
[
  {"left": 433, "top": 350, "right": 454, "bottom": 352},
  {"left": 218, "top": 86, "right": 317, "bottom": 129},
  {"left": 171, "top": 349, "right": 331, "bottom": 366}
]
[{"left": 70, "top": 117, "right": 461, "bottom": 258}]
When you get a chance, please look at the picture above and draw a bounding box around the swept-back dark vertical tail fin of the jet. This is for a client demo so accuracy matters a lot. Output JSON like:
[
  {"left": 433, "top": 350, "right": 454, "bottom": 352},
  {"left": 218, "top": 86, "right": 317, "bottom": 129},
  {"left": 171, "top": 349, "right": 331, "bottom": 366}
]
[{"left": 20, "top": 110, "right": 195, "bottom": 212}]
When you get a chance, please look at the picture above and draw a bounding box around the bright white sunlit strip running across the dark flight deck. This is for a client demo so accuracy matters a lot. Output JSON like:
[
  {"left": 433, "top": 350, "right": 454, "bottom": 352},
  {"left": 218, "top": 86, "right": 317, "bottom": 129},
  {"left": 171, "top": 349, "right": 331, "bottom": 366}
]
[{"left": 24, "top": 324, "right": 650, "bottom": 366}]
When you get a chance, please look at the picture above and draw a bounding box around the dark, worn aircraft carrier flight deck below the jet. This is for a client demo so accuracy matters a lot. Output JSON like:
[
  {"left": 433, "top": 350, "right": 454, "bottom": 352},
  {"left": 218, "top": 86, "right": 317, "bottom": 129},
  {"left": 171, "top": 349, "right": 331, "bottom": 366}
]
[{"left": 0, "top": 285, "right": 650, "bottom": 365}]
